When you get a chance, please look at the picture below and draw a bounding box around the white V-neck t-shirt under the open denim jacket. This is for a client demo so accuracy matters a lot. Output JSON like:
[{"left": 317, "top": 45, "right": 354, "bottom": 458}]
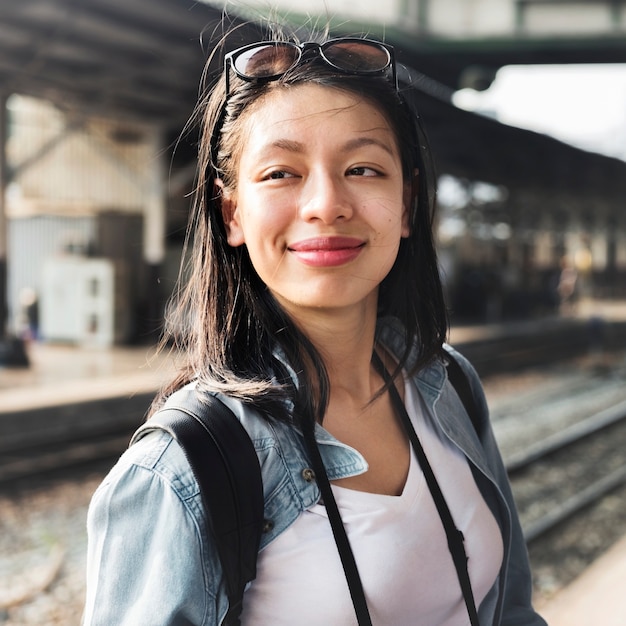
[{"left": 242, "top": 376, "right": 503, "bottom": 626}]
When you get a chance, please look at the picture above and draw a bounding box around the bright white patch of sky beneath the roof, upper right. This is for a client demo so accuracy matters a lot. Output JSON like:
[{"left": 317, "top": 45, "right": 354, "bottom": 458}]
[{"left": 455, "top": 64, "right": 626, "bottom": 160}]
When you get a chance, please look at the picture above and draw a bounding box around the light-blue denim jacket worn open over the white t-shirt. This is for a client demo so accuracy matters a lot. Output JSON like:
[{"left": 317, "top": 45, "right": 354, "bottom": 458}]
[{"left": 83, "top": 321, "right": 545, "bottom": 626}]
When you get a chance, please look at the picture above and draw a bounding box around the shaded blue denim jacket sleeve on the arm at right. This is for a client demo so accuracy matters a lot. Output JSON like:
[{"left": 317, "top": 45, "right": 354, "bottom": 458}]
[{"left": 444, "top": 351, "right": 546, "bottom": 626}]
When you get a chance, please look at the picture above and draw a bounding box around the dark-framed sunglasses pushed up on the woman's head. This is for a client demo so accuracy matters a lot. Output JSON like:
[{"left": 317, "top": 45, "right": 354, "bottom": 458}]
[{"left": 224, "top": 37, "right": 398, "bottom": 97}]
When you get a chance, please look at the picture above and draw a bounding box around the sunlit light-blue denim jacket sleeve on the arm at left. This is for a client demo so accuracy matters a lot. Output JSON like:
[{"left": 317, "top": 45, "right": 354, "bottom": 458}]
[{"left": 83, "top": 432, "right": 227, "bottom": 626}]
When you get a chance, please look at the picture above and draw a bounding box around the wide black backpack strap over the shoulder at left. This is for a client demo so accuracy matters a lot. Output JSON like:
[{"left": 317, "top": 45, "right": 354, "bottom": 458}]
[{"left": 131, "top": 388, "right": 263, "bottom": 624}]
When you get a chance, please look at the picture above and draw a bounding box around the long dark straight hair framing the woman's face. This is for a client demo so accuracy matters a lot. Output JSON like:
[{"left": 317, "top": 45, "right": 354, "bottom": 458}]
[{"left": 155, "top": 33, "right": 448, "bottom": 423}]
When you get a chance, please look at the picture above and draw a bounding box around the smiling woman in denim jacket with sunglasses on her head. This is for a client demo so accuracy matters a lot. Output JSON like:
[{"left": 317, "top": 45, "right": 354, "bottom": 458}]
[{"left": 85, "top": 29, "right": 544, "bottom": 626}]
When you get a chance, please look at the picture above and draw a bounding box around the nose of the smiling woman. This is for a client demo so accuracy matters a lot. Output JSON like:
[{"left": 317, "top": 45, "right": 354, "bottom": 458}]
[{"left": 300, "top": 172, "right": 353, "bottom": 224}]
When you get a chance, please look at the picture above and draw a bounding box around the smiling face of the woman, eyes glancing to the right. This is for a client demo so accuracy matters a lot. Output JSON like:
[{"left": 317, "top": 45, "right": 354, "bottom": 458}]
[{"left": 223, "top": 84, "right": 410, "bottom": 318}]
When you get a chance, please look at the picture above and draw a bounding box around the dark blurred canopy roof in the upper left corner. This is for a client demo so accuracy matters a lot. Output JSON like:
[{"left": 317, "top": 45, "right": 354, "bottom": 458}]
[{"left": 0, "top": 0, "right": 254, "bottom": 128}]
